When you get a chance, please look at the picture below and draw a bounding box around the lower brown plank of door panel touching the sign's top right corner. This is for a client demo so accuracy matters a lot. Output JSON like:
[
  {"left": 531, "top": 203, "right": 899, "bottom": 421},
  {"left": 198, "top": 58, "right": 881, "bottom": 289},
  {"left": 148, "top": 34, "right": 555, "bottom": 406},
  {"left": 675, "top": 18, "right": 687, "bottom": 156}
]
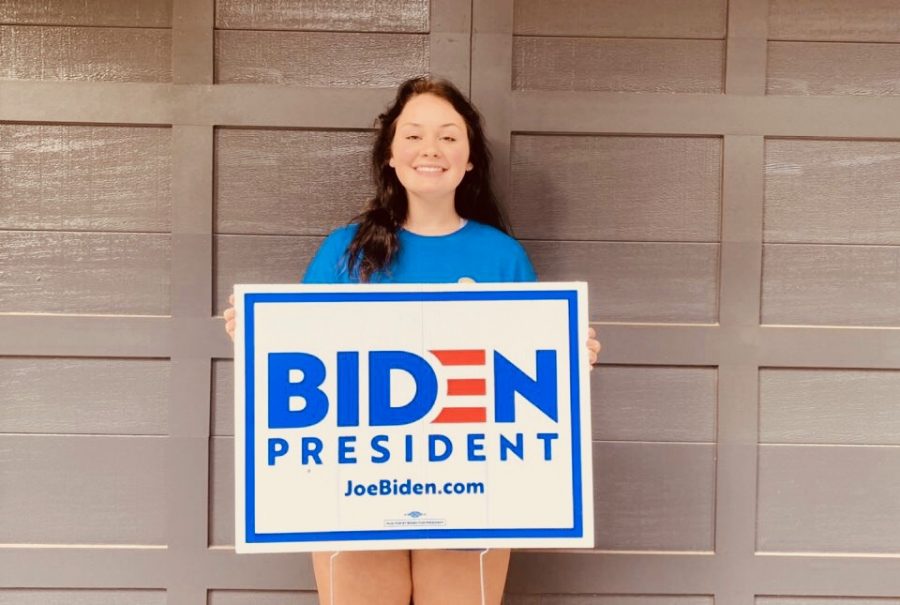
[{"left": 523, "top": 241, "right": 719, "bottom": 323}]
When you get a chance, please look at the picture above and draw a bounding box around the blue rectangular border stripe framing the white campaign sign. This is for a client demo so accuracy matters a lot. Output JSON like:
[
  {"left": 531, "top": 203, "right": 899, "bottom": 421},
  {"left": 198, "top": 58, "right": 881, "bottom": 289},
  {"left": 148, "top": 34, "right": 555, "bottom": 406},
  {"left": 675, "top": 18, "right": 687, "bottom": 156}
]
[{"left": 243, "top": 290, "right": 584, "bottom": 544}]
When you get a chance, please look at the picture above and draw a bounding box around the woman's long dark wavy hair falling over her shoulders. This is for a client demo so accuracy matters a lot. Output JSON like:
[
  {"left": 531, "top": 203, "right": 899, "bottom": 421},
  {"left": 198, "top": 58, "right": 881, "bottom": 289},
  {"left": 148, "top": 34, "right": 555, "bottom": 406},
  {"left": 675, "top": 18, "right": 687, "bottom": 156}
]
[{"left": 347, "top": 76, "right": 510, "bottom": 282}]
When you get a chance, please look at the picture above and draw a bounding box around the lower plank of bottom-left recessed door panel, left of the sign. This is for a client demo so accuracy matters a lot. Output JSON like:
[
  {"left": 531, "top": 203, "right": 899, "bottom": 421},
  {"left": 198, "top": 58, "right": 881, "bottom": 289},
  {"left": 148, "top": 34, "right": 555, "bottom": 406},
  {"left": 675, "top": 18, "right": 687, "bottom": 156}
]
[{"left": 0, "top": 435, "right": 166, "bottom": 545}]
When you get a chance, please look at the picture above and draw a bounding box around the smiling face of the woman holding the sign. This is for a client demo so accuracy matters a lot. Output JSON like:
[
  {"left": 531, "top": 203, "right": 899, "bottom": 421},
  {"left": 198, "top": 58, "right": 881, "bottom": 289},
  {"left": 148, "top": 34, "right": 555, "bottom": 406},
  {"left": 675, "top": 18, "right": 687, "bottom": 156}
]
[{"left": 388, "top": 93, "right": 472, "bottom": 208}]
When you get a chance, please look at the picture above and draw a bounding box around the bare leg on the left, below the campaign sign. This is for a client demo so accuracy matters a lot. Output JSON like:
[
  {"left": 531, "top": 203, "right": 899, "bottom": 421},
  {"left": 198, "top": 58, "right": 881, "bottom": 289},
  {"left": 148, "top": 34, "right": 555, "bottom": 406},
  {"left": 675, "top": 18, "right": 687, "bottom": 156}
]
[{"left": 313, "top": 550, "right": 412, "bottom": 605}]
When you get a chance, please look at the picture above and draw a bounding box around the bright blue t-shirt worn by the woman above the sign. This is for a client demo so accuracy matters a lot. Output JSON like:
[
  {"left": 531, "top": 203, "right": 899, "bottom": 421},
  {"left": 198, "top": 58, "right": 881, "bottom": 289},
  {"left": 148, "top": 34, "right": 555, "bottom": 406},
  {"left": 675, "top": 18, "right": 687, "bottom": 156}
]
[{"left": 303, "top": 220, "right": 536, "bottom": 284}]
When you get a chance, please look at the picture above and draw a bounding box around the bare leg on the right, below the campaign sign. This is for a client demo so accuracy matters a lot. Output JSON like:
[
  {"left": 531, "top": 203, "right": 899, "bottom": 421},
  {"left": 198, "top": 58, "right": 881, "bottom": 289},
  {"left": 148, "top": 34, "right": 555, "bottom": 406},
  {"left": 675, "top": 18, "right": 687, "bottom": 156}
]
[{"left": 412, "top": 548, "right": 509, "bottom": 605}]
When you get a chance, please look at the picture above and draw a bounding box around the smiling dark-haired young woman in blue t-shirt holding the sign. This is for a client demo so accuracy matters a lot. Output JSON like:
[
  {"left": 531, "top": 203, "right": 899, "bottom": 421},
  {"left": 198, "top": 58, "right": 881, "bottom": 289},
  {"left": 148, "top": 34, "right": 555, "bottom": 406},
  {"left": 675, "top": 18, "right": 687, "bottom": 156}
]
[{"left": 225, "top": 77, "right": 600, "bottom": 605}]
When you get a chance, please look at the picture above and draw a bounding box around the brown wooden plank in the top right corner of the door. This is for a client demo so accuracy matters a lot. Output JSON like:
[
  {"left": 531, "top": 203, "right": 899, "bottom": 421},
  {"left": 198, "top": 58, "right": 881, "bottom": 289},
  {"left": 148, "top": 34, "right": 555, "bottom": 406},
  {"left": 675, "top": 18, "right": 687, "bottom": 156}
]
[{"left": 769, "top": 0, "right": 900, "bottom": 42}]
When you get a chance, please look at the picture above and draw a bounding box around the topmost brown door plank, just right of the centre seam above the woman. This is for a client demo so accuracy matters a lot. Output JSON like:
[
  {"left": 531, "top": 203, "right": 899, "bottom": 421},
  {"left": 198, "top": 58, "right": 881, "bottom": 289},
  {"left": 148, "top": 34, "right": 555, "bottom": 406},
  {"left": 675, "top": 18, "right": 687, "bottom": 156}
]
[{"left": 513, "top": 0, "right": 727, "bottom": 40}]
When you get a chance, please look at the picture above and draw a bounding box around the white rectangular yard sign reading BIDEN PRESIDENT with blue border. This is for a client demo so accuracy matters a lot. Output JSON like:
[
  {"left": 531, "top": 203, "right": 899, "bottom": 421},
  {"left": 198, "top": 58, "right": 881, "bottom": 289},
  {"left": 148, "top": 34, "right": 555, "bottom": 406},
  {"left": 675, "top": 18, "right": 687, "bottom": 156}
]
[{"left": 235, "top": 282, "right": 594, "bottom": 552}]
